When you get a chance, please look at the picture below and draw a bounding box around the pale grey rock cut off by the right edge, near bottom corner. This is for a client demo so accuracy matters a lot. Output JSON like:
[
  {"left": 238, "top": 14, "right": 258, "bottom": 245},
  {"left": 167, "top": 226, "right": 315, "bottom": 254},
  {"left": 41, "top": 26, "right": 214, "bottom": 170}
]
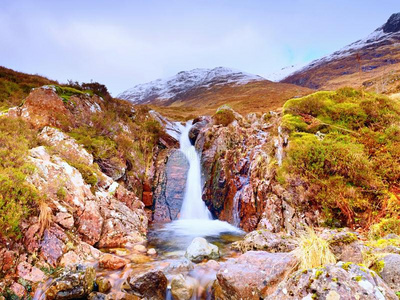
[{"left": 379, "top": 254, "right": 400, "bottom": 291}]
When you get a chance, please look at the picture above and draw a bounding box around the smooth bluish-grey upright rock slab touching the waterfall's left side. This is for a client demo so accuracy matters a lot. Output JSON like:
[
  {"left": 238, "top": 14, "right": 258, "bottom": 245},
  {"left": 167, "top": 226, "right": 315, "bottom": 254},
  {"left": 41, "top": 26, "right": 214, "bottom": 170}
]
[{"left": 153, "top": 149, "right": 189, "bottom": 221}]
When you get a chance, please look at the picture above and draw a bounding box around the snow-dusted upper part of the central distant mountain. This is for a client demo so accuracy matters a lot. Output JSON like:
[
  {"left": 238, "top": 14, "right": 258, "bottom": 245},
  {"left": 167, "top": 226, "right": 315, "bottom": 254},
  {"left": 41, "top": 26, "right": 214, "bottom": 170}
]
[{"left": 118, "top": 67, "right": 265, "bottom": 104}]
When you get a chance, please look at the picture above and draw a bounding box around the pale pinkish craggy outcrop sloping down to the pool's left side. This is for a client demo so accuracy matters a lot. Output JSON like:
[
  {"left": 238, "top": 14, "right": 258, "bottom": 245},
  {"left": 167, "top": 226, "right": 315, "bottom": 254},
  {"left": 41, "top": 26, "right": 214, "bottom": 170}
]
[{"left": 29, "top": 147, "right": 147, "bottom": 251}]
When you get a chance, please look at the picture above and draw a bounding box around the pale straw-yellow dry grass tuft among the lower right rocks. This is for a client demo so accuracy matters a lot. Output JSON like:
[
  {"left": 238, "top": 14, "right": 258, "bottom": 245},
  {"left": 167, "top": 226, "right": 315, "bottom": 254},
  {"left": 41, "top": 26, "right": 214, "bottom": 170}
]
[{"left": 294, "top": 227, "right": 336, "bottom": 270}]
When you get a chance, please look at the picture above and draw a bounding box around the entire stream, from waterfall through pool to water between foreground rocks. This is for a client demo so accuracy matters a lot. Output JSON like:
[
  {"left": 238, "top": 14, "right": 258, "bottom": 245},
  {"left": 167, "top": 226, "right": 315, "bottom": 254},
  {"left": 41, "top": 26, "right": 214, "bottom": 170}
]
[{"left": 34, "top": 121, "right": 243, "bottom": 300}]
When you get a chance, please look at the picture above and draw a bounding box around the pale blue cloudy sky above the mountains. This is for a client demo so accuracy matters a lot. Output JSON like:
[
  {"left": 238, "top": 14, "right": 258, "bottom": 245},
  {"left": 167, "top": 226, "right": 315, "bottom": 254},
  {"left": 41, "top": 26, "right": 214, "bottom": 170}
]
[{"left": 0, "top": 0, "right": 400, "bottom": 96}]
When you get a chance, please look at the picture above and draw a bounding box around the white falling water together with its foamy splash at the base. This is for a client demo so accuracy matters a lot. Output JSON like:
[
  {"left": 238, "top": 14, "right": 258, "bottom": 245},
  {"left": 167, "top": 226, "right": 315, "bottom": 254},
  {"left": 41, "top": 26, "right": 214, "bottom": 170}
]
[{"left": 160, "top": 121, "right": 242, "bottom": 242}]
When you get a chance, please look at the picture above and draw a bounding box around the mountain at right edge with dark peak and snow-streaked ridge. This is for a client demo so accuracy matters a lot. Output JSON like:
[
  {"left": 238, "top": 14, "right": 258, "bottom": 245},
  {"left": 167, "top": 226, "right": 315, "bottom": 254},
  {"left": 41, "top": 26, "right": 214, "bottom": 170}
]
[{"left": 281, "top": 13, "right": 400, "bottom": 93}]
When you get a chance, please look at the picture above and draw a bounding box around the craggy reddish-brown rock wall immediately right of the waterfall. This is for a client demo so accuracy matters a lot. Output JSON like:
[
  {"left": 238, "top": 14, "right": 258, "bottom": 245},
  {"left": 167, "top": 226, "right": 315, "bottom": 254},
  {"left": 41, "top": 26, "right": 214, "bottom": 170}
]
[{"left": 196, "top": 112, "right": 307, "bottom": 232}]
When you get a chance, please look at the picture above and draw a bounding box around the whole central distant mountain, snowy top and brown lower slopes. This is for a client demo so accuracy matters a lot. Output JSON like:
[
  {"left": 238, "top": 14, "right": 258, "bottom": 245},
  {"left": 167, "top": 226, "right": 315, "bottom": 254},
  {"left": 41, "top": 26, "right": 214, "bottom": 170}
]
[{"left": 118, "top": 67, "right": 311, "bottom": 118}]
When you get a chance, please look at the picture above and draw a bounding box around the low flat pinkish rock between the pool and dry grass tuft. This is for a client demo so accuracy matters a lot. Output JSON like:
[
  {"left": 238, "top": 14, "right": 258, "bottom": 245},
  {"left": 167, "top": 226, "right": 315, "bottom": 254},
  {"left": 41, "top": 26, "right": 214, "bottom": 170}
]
[{"left": 232, "top": 229, "right": 296, "bottom": 252}]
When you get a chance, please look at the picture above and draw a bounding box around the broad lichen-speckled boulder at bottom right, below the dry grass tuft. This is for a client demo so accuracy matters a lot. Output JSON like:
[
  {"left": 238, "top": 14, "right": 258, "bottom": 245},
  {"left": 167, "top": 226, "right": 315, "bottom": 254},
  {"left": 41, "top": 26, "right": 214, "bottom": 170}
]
[{"left": 268, "top": 262, "right": 397, "bottom": 300}]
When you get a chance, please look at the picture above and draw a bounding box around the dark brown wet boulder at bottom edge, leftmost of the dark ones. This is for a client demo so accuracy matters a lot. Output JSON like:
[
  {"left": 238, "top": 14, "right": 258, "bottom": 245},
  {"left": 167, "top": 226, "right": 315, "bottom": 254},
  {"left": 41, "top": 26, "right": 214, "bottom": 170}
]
[{"left": 46, "top": 266, "right": 96, "bottom": 300}]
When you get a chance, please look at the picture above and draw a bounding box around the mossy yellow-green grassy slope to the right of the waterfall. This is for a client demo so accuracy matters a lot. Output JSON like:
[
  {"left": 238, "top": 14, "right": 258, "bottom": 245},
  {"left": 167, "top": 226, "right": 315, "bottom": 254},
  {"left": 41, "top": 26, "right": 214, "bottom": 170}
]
[{"left": 279, "top": 88, "right": 400, "bottom": 232}]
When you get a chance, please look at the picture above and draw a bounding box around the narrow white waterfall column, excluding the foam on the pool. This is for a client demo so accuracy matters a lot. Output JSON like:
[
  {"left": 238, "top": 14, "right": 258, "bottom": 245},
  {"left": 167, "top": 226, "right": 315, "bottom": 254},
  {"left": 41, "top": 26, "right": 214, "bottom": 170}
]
[{"left": 179, "top": 121, "right": 212, "bottom": 220}]
